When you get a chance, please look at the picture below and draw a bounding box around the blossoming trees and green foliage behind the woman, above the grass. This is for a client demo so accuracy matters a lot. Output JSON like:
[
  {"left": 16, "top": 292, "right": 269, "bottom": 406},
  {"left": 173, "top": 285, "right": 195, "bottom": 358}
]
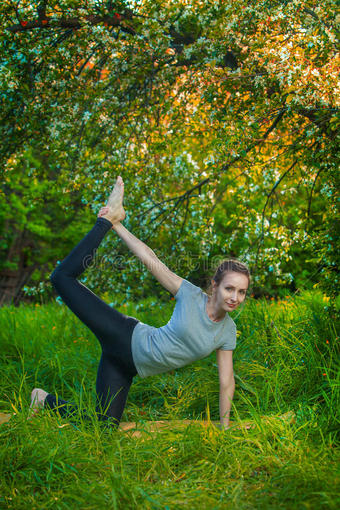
[{"left": 0, "top": 0, "right": 340, "bottom": 304}]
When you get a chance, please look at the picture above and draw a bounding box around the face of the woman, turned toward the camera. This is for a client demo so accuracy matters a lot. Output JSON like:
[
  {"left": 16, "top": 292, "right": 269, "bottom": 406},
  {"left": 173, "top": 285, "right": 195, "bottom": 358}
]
[{"left": 213, "top": 271, "right": 249, "bottom": 312}]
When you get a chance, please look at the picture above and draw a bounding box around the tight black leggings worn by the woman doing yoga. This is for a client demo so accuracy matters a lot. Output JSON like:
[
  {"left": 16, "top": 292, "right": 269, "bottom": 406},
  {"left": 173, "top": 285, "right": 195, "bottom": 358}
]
[{"left": 45, "top": 218, "right": 138, "bottom": 425}]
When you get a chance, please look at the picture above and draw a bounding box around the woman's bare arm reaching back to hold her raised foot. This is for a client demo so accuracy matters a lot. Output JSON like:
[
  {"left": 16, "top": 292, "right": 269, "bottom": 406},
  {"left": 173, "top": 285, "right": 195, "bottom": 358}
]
[{"left": 112, "top": 222, "right": 183, "bottom": 295}]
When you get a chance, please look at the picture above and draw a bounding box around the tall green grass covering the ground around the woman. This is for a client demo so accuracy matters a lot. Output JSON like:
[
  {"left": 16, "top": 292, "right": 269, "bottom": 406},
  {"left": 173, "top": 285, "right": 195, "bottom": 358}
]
[{"left": 0, "top": 292, "right": 340, "bottom": 510}]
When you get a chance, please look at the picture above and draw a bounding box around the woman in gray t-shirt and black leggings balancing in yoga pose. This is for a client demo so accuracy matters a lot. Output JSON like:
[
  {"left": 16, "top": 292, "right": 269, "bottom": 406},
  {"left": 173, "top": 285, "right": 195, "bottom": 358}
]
[{"left": 31, "top": 176, "right": 250, "bottom": 428}]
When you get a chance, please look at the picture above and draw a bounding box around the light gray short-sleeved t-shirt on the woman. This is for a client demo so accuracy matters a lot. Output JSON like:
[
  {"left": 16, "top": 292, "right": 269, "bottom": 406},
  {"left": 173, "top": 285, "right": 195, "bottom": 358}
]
[{"left": 132, "top": 280, "right": 236, "bottom": 377}]
